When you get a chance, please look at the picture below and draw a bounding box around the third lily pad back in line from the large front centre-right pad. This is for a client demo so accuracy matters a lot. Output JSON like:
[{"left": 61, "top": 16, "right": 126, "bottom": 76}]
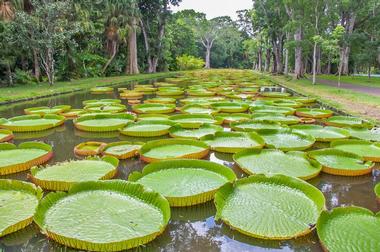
[{"left": 257, "top": 129, "right": 315, "bottom": 151}]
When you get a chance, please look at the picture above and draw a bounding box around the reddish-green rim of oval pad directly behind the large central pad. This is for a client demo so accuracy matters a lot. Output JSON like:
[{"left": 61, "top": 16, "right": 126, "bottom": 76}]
[{"left": 139, "top": 138, "right": 210, "bottom": 163}]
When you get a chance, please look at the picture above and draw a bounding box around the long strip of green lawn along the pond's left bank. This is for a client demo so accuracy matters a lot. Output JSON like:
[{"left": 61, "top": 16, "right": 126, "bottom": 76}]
[{"left": 0, "top": 72, "right": 176, "bottom": 102}]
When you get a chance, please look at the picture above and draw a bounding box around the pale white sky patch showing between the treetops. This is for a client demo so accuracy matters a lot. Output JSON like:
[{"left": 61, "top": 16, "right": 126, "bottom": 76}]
[{"left": 172, "top": 0, "right": 252, "bottom": 19}]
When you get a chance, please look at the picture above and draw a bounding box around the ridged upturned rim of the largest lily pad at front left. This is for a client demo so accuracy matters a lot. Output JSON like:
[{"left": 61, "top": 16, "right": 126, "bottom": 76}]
[{"left": 34, "top": 180, "right": 171, "bottom": 251}]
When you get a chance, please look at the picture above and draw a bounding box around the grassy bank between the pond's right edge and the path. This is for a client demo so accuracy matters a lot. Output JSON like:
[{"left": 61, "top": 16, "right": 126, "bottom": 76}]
[{"left": 271, "top": 73, "right": 380, "bottom": 124}]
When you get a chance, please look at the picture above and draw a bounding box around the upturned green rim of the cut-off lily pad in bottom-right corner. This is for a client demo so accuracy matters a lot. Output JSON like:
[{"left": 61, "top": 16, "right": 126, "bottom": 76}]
[{"left": 316, "top": 206, "right": 380, "bottom": 251}]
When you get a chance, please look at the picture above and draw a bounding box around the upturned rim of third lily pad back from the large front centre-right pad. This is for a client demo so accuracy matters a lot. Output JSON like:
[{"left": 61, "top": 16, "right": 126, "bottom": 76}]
[{"left": 256, "top": 128, "right": 316, "bottom": 151}]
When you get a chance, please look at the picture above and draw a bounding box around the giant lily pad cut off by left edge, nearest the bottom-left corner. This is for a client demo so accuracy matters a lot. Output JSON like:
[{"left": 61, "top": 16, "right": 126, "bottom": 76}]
[{"left": 0, "top": 179, "right": 42, "bottom": 237}]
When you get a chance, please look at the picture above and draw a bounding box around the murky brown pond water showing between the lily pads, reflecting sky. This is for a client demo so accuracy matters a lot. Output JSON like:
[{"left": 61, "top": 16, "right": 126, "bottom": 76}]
[{"left": 0, "top": 79, "right": 380, "bottom": 252}]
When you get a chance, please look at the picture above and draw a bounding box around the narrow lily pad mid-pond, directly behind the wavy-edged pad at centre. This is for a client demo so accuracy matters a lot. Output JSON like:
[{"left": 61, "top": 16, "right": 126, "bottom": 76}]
[{"left": 169, "top": 114, "right": 223, "bottom": 128}]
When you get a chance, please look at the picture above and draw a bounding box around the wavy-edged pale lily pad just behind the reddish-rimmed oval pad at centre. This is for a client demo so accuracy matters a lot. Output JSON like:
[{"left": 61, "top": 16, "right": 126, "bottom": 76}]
[{"left": 169, "top": 124, "right": 223, "bottom": 139}]
